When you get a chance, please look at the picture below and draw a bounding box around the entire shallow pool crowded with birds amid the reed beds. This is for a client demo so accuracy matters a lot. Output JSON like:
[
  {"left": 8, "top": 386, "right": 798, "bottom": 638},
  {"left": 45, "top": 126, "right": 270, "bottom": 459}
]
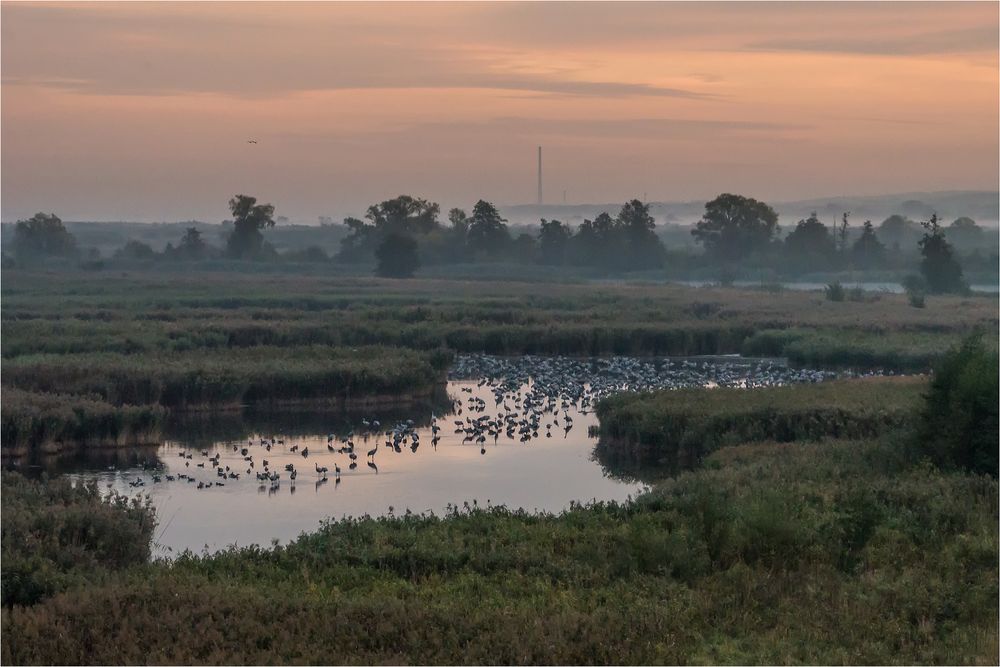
[{"left": 17, "top": 356, "right": 844, "bottom": 557}]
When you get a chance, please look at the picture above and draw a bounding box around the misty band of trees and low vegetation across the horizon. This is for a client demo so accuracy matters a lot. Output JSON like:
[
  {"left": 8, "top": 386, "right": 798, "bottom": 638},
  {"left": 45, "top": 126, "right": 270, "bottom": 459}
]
[{"left": 3, "top": 193, "right": 997, "bottom": 292}]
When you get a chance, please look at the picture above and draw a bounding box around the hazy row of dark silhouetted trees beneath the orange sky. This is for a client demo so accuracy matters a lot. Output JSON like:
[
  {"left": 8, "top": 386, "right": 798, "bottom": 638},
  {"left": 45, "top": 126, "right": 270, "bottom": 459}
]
[{"left": 5, "top": 193, "right": 984, "bottom": 293}]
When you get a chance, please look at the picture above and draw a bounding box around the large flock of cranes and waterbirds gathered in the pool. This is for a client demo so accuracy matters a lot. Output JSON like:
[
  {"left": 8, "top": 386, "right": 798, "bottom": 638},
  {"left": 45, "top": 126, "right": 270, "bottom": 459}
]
[{"left": 115, "top": 355, "right": 844, "bottom": 493}]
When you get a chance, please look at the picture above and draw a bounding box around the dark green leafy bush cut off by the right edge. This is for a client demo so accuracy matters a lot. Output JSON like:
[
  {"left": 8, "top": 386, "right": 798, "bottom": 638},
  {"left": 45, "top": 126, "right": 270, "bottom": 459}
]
[{"left": 915, "top": 336, "right": 1000, "bottom": 477}]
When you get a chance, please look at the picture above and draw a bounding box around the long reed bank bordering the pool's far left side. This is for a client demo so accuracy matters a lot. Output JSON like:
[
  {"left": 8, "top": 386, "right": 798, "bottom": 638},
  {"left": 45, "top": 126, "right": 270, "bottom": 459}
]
[{"left": 4, "top": 346, "right": 450, "bottom": 408}]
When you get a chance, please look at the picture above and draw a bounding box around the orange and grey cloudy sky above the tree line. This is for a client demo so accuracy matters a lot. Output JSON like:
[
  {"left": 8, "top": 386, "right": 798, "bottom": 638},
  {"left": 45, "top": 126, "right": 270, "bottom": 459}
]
[{"left": 0, "top": 2, "right": 1000, "bottom": 222}]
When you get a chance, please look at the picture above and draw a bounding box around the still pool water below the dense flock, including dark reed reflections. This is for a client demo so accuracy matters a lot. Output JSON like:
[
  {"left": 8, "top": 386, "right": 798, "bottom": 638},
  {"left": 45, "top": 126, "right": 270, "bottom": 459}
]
[{"left": 63, "top": 381, "right": 643, "bottom": 556}]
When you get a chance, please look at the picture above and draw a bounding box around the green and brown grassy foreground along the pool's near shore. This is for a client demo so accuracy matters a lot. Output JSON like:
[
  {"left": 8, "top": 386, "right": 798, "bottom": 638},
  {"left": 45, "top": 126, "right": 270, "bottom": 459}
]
[{"left": 2, "top": 440, "right": 998, "bottom": 664}]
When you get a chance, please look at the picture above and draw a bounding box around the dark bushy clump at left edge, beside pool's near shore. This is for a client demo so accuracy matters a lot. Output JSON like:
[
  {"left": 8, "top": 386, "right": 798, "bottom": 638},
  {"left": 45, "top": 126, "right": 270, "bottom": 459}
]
[{"left": 0, "top": 472, "right": 155, "bottom": 607}]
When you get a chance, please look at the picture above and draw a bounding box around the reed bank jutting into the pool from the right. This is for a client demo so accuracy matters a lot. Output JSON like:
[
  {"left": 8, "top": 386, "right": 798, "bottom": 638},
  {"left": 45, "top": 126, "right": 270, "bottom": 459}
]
[{"left": 596, "top": 376, "right": 927, "bottom": 476}]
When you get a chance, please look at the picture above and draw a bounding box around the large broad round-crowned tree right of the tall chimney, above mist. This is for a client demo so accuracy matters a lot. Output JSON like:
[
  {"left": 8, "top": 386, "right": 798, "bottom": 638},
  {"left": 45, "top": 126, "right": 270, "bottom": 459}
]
[{"left": 691, "top": 193, "right": 778, "bottom": 260}]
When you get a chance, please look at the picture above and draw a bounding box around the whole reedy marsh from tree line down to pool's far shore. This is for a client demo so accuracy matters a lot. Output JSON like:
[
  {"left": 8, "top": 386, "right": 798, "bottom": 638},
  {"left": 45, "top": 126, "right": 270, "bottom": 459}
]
[{"left": 0, "top": 271, "right": 997, "bottom": 456}]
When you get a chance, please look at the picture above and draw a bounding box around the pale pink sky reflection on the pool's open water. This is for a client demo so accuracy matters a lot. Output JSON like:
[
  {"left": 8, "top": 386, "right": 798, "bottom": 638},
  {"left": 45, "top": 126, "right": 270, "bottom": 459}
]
[{"left": 62, "top": 382, "right": 642, "bottom": 554}]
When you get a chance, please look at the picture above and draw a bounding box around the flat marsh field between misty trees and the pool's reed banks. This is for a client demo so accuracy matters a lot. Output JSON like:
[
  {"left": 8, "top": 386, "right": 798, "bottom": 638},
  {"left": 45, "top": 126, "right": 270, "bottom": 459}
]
[{"left": 2, "top": 271, "right": 998, "bottom": 366}]
